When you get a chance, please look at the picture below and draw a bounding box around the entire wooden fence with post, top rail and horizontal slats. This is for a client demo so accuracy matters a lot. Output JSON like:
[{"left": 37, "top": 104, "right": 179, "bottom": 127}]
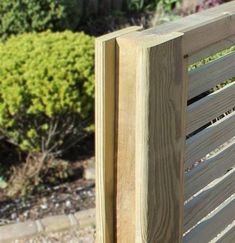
[{"left": 96, "top": 1, "right": 235, "bottom": 243}]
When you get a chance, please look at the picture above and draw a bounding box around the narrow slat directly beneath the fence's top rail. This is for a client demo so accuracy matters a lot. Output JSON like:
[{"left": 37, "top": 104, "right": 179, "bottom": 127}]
[{"left": 188, "top": 36, "right": 235, "bottom": 64}]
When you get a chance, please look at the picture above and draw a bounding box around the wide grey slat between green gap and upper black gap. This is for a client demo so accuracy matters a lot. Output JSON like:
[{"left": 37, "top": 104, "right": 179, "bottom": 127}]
[{"left": 188, "top": 52, "right": 235, "bottom": 99}]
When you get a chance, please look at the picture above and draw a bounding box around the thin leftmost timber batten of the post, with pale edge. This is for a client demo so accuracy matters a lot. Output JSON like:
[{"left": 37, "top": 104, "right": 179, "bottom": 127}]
[{"left": 95, "top": 27, "right": 140, "bottom": 243}]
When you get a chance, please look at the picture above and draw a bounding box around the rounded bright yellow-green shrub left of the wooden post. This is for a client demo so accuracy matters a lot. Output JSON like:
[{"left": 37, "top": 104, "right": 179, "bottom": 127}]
[{"left": 0, "top": 31, "right": 94, "bottom": 154}]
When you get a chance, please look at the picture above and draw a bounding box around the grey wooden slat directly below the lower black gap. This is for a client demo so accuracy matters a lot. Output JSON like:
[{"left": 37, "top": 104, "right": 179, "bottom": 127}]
[{"left": 185, "top": 112, "right": 235, "bottom": 168}]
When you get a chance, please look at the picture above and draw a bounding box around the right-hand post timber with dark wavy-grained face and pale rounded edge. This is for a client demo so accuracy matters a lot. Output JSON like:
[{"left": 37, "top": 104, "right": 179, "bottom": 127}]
[{"left": 132, "top": 33, "right": 187, "bottom": 243}]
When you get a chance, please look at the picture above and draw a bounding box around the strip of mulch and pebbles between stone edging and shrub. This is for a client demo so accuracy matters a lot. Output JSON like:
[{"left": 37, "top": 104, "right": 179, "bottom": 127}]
[{"left": 0, "top": 161, "right": 95, "bottom": 228}]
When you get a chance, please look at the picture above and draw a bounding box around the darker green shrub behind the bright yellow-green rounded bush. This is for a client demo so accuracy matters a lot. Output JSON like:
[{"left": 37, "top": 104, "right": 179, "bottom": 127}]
[{"left": 0, "top": 0, "right": 82, "bottom": 38}]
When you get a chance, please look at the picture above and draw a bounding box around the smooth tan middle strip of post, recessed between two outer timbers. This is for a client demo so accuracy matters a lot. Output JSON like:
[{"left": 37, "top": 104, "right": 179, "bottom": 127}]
[{"left": 116, "top": 32, "right": 140, "bottom": 243}]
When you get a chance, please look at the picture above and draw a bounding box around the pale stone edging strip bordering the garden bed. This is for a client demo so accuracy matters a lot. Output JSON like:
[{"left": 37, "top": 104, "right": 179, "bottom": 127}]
[{"left": 0, "top": 208, "right": 95, "bottom": 243}]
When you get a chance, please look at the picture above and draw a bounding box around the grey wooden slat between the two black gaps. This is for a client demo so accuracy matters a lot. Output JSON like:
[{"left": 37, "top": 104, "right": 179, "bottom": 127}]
[{"left": 187, "top": 82, "right": 235, "bottom": 134}]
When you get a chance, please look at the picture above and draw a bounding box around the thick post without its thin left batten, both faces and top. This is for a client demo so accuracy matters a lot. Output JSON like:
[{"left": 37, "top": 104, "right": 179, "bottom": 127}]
[{"left": 116, "top": 33, "right": 187, "bottom": 243}]
